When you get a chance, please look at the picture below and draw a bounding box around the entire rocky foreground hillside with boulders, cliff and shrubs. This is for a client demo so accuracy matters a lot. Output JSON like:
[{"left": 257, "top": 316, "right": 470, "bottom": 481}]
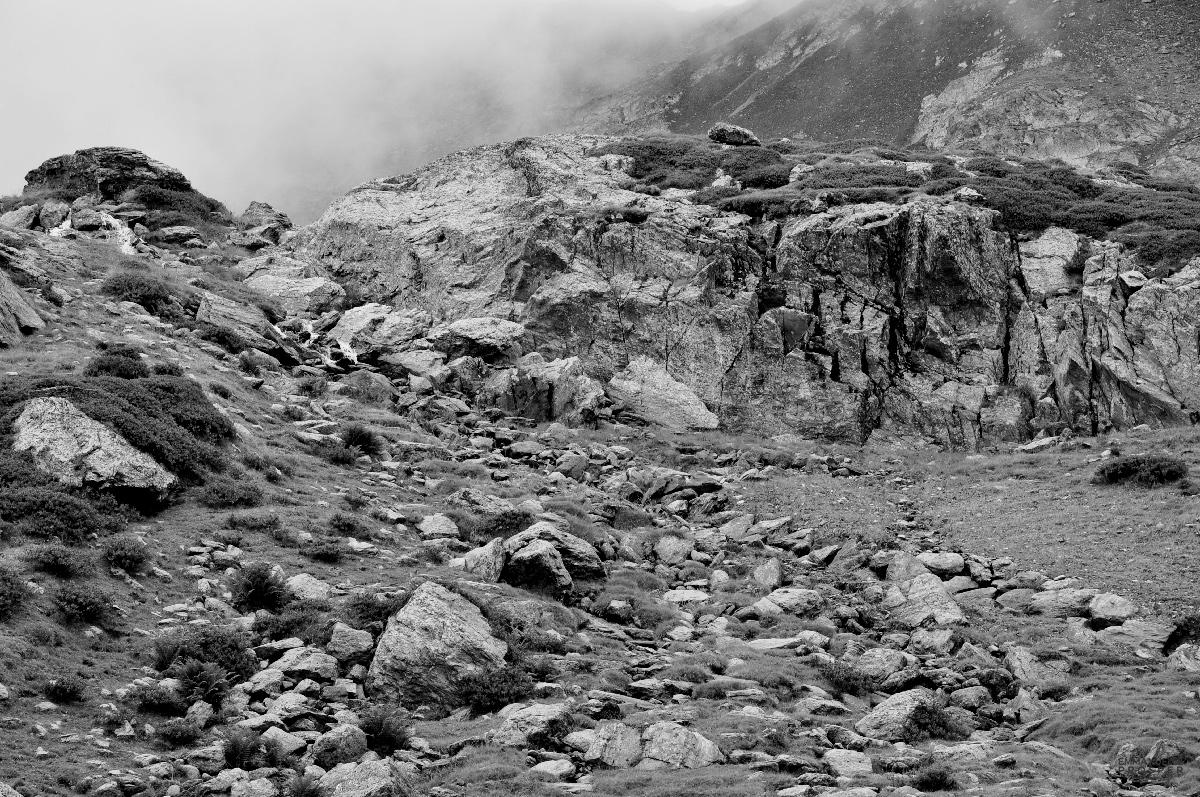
[{"left": 0, "top": 139, "right": 1200, "bottom": 797}]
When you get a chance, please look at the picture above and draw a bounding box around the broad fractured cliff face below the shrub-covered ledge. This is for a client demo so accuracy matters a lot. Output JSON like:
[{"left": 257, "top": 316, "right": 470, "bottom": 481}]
[{"left": 296, "top": 136, "right": 1200, "bottom": 448}]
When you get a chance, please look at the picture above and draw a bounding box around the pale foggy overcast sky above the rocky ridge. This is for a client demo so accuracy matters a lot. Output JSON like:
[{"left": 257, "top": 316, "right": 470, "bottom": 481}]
[{"left": 0, "top": 0, "right": 740, "bottom": 221}]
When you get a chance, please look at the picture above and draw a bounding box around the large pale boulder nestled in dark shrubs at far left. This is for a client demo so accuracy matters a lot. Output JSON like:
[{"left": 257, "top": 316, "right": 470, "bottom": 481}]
[{"left": 12, "top": 397, "right": 175, "bottom": 498}]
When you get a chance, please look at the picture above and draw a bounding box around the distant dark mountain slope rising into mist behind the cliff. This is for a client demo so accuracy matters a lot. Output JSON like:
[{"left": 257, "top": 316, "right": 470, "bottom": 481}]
[{"left": 580, "top": 0, "right": 1200, "bottom": 180}]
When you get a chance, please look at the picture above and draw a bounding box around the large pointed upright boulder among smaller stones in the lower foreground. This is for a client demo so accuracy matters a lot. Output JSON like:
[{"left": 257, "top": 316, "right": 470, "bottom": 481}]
[{"left": 365, "top": 581, "right": 508, "bottom": 706}]
